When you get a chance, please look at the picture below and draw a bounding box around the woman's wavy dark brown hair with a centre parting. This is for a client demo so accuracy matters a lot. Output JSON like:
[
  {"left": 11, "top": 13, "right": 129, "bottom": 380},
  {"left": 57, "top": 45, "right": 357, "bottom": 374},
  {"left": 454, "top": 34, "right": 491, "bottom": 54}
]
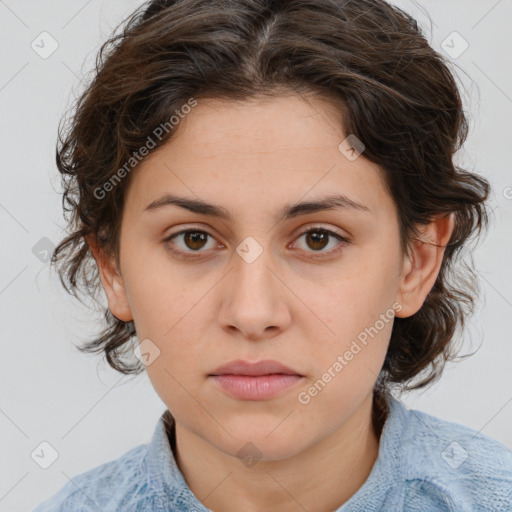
[{"left": 51, "top": 0, "right": 490, "bottom": 410}]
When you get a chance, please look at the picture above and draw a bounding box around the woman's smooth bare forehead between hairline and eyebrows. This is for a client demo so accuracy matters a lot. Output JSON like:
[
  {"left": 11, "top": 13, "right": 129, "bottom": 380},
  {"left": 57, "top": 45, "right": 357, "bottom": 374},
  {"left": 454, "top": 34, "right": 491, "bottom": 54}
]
[{"left": 127, "top": 94, "right": 393, "bottom": 221}]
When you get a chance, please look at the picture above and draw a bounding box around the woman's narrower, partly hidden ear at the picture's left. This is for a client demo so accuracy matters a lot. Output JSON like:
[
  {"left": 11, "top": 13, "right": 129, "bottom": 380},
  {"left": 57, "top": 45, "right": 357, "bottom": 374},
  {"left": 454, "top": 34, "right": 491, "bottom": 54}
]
[{"left": 86, "top": 236, "right": 133, "bottom": 322}]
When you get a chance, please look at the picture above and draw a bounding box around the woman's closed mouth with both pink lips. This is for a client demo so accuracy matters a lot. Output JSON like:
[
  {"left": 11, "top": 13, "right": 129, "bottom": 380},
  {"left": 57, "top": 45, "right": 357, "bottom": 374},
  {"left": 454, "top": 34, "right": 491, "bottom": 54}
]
[{"left": 208, "top": 360, "right": 305, "bottom": 401}]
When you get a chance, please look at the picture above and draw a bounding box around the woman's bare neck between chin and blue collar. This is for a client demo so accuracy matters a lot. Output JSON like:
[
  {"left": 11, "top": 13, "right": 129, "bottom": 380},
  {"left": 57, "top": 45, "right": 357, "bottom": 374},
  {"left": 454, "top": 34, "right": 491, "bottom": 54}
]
[{"left": 171, "top": 395, "right": 386, "bottom": 512}]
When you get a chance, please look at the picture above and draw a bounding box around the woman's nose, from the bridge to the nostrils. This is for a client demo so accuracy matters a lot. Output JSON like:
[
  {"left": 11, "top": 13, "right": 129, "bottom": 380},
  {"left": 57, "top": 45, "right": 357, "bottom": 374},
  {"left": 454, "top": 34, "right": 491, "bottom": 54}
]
[{"left": 218, "top": 242, "right": 291, "bottom": 341}]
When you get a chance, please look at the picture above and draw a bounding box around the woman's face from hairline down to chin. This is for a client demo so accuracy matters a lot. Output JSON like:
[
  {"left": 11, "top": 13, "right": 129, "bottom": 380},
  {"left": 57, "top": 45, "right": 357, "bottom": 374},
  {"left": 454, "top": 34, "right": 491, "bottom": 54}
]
[{"left": 95, "top": 91, "right": 432, "bottom": 460}]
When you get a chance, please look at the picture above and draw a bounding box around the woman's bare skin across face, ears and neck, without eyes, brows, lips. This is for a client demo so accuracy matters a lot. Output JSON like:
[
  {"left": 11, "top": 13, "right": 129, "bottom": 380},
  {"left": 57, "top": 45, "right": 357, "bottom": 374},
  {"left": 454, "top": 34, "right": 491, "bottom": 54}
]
[{"left": 89, "top": 93, "right": 453, "bottom": 512}]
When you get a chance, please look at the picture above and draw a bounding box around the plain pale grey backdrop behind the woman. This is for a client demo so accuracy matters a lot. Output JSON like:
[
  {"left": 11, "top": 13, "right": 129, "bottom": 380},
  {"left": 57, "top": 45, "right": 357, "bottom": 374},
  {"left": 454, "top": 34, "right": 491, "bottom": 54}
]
[{"left": 0, "top": 0, "right": 512, "bottom": 512}]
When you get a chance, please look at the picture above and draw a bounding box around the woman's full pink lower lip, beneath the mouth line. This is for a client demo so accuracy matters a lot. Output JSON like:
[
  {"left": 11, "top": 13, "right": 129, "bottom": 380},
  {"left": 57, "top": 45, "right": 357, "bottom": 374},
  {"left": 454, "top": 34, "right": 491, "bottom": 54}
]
[{"left": 211, "top": 373, "right": 303, "bottom": 400}]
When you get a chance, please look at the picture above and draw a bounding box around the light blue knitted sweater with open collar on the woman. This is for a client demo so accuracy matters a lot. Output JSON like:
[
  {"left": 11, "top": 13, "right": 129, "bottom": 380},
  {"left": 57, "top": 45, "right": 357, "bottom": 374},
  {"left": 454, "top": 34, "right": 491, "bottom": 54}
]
[{"left": 33, "top": 397, "right": 512, "bottom": 512}]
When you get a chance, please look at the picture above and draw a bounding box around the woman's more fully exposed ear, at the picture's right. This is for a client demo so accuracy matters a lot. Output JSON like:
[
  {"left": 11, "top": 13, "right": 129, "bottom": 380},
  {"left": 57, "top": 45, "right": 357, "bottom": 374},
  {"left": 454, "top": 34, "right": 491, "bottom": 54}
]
[{"left": 396, "top": 213, "right": 455, "bottom": 318}]
